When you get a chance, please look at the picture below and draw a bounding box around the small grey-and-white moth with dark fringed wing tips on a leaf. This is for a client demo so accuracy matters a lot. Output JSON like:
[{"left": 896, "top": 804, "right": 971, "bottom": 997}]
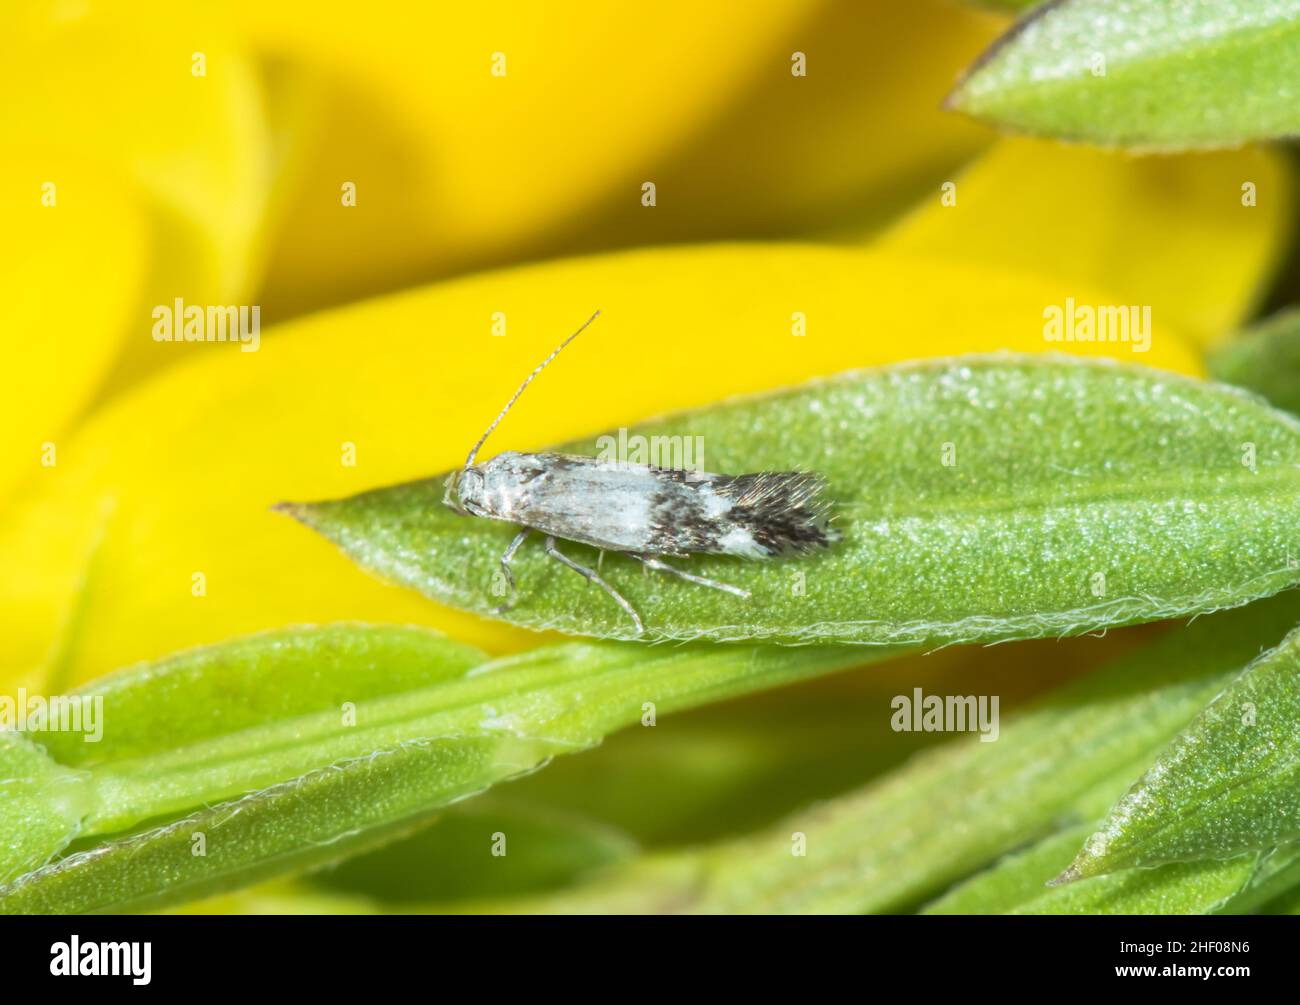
[{"left": 443, "top": 311, "right": 837, "bottom": 634}]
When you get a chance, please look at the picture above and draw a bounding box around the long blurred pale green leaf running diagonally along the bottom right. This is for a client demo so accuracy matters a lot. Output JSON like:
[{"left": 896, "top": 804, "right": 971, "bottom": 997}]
[{"left": 434, "top": 594, "right": 1300, "bottom": 914}]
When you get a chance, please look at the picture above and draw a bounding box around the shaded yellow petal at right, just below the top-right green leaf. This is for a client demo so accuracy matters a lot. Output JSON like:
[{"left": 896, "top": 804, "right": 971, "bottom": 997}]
[{"left": 880, "top": 139, "right": 1292, "bottom": 343}]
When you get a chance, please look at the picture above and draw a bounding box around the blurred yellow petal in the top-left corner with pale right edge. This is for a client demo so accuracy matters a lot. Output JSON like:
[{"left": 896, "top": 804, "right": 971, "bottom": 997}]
[{"left": 0, "top": 0, "right": 269, "bottom": 382}]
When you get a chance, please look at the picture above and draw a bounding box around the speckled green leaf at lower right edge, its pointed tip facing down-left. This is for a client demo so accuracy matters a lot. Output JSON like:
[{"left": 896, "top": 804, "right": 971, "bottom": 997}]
[{"left": 1061, "top": 611, "right": 1300, "bottom": 881}]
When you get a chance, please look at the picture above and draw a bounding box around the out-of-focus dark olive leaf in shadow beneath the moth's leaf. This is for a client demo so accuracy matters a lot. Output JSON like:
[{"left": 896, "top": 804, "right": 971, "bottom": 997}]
[{"left": 499, "top": 627, "right": 1118, "bottom": 848}]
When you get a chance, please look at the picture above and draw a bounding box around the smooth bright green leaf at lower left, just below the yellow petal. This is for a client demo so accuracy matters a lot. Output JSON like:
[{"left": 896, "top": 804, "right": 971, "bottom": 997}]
[{"left": 43, "top": 625, "right": 484, "bottom": 836}]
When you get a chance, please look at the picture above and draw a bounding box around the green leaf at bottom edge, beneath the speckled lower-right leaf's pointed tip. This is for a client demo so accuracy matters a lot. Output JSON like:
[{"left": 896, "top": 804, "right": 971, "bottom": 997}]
[{"left": 926, "top": 827, "right": 1268, "bottom": 914}]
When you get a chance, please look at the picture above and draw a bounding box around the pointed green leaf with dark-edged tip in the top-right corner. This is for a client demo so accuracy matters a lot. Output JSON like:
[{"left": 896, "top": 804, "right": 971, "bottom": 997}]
[{"left": 949, "top": 0, "right": 1300, "bottom": 148}]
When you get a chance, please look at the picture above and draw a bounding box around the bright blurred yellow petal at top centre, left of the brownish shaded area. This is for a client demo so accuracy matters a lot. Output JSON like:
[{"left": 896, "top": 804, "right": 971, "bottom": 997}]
[{"left": 235, "top": 0, "right": 806, "bottom": 299}]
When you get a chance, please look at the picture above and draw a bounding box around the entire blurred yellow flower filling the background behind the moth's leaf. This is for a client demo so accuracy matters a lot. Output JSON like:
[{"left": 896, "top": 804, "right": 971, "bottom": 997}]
[{"left": 0, "top": 0, "right": 1291, "bottom": 689}]
